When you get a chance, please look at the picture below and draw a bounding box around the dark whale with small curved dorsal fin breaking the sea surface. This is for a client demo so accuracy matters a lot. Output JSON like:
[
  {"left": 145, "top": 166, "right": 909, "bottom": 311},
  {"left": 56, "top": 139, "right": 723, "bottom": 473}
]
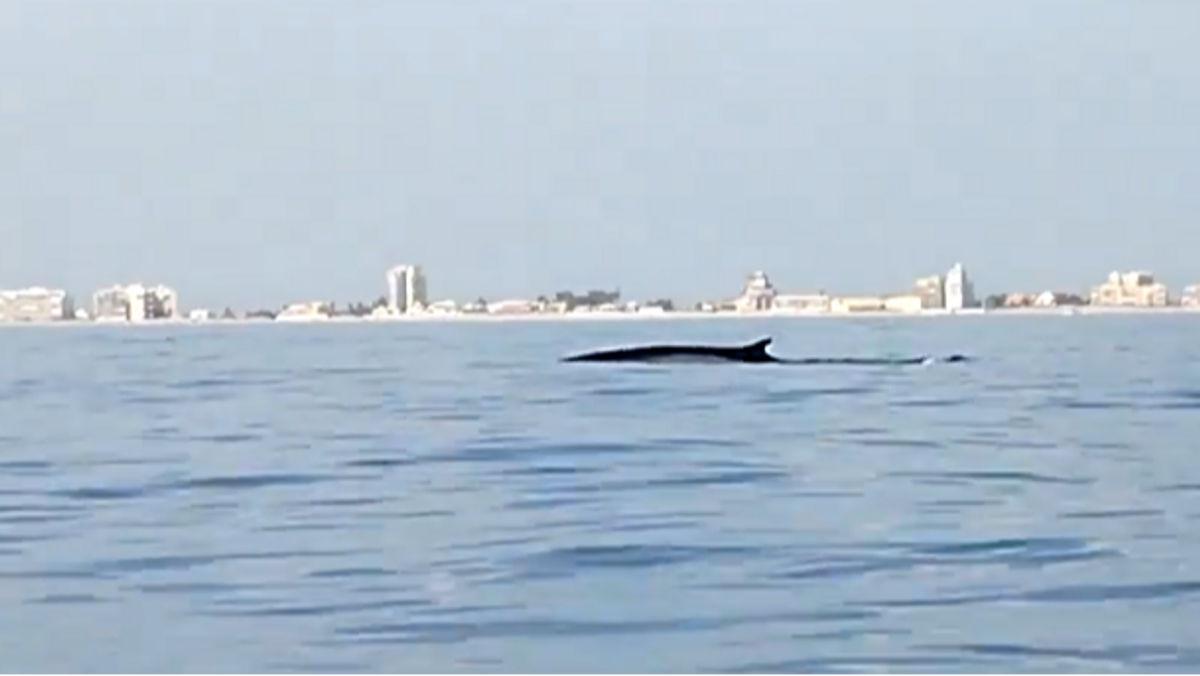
[{"left": 562, "top": 337, "right": 967, "bottom": 366}]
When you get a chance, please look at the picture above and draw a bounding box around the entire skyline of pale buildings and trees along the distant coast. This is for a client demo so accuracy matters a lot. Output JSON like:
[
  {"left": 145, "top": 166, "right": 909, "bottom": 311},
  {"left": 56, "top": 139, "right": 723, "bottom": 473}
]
[{"left": 7, "top": 263, "right": 1200, "bottom": 323}]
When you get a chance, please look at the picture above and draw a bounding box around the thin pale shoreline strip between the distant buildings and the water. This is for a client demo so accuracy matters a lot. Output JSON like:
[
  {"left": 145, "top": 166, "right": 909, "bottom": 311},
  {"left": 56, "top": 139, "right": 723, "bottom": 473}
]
[{"left": 0, "top": 305, "right": 1200, "bottom": 329}]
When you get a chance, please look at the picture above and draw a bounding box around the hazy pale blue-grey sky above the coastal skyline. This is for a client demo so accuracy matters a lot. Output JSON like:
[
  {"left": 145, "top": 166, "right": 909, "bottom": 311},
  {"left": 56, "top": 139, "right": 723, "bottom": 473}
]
[{"left": 0, "top": 0, "right": 1200, "bottom": 306}]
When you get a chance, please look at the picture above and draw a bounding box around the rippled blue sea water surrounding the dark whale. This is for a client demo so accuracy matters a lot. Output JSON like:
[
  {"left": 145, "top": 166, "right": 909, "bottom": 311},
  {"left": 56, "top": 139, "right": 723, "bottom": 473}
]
[{"left": 0, "top": 316, "right": 1200, "bottom": 676}]
